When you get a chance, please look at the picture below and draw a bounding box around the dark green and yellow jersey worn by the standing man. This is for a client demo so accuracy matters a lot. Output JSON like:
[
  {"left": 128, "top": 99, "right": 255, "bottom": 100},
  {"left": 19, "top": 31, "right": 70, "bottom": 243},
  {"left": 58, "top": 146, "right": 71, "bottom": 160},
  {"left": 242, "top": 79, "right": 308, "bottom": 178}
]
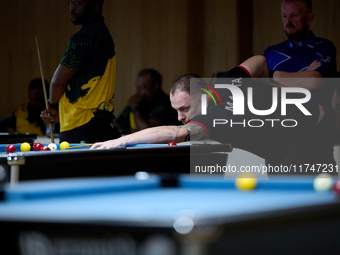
[{"left": 59, "top": 17, "right": 116, "bottom": 132}]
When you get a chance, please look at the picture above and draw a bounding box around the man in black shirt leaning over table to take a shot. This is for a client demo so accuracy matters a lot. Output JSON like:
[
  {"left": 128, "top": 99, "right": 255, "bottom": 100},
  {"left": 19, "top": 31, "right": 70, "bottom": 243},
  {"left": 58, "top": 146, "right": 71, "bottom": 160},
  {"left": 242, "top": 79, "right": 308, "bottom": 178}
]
[{"left": 91, "top": 56, "right": 325, "bottom": 165}]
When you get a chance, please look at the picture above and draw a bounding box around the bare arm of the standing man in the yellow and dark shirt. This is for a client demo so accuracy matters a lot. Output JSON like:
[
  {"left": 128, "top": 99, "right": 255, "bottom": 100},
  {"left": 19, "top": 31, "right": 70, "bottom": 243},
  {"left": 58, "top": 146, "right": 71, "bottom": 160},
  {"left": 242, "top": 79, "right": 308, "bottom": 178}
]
[{"left": 49, "top": 65, "right": 75, "bottom": 104}]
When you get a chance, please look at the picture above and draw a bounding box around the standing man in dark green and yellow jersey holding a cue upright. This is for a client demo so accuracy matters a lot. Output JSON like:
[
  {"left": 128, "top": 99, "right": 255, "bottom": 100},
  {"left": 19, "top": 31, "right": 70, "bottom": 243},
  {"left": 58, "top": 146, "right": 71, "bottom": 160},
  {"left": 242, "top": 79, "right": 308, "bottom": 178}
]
[{"left": 41, "top": 0, "right": 120, "bottom": 143}]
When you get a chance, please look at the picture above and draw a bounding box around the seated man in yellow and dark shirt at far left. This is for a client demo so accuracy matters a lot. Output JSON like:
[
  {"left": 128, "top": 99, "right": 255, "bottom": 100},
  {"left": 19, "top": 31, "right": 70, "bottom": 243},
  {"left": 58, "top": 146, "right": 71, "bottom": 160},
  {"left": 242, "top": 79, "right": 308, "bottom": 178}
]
[{"left": 0, "top": 79, "right": 55, "bottom": 136}]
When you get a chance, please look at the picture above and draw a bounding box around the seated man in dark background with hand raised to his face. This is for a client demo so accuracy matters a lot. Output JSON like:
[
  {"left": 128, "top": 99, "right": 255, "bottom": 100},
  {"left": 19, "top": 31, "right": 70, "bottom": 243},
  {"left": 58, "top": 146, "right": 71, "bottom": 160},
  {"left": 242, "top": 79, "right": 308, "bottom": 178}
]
[{"left": 114, "top": 69, "right": 178, "bottom": 134}]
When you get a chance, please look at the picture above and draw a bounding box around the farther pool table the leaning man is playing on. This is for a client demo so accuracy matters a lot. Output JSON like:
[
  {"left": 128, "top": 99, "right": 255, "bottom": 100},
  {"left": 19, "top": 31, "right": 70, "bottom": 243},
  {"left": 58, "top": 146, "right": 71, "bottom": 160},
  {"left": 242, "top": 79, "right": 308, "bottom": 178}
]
[{"left": 0, "top": 144, "right": 232, "bottom": 185}]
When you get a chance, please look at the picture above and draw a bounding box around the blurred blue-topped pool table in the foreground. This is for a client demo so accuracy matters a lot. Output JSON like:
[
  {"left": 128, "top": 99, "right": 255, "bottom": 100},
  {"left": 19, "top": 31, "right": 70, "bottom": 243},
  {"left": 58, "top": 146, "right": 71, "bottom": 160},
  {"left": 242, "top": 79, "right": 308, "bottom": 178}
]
[{"left": 0, "top": 174, "right": 340, "bottom": 255}]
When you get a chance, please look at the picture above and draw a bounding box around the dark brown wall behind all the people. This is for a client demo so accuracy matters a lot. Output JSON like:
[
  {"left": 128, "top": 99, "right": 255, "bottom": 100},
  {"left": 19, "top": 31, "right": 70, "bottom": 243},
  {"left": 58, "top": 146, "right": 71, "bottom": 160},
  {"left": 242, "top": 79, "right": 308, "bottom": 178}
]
[{"left": 0, "top": 0, "right": 340, "bottom": 118}]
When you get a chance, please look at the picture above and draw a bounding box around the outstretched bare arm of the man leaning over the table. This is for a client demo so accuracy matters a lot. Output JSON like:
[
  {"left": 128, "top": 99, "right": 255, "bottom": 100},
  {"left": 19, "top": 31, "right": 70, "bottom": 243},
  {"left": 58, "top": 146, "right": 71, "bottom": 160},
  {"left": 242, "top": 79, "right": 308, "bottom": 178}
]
[{"left": 91, "top": 123, "right": 206, "bottom": 149}]
